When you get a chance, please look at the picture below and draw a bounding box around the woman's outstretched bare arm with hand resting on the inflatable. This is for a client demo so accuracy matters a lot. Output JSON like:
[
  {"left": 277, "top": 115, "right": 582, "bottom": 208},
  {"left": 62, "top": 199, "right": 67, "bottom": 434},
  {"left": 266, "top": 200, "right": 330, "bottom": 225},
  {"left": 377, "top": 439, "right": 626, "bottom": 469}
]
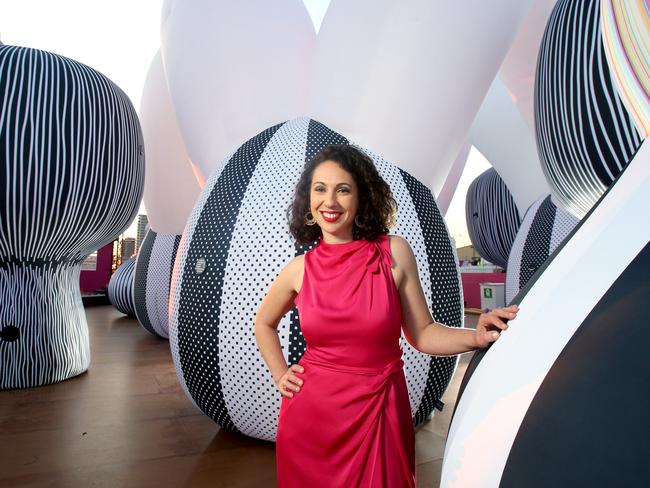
[{"left": 390, "top": 236, "right": 518, "bottom": 356}]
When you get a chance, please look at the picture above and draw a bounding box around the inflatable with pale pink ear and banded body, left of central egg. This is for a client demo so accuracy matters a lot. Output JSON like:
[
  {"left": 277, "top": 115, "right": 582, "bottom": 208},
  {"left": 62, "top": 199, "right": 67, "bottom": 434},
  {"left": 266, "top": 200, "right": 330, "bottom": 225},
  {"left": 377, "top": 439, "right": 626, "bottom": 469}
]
[{"left": 134, "top": 52, "right": 203, "bottom": 338}]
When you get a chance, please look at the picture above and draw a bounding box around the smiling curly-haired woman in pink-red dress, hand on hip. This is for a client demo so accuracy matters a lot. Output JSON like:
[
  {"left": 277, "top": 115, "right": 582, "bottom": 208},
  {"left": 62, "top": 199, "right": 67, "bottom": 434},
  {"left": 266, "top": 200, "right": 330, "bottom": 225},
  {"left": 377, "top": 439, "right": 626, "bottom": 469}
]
[{"left": 255, "top": 145, "right": 518, "bottom": 488}]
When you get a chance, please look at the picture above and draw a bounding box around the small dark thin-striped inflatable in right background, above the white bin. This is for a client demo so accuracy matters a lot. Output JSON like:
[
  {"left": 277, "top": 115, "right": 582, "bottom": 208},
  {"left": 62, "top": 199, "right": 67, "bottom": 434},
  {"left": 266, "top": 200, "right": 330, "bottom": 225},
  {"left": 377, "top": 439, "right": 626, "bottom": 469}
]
[{"left": 465, "top": 168, "right": 520, "bottom": 268}]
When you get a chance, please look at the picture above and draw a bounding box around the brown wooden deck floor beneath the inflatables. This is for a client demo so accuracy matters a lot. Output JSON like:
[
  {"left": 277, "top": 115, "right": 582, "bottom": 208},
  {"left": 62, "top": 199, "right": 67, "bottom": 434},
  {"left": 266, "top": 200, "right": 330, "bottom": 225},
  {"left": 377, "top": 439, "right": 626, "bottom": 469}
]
[{"left": 0, "top": 306, "right": 475, "bottom": 488}]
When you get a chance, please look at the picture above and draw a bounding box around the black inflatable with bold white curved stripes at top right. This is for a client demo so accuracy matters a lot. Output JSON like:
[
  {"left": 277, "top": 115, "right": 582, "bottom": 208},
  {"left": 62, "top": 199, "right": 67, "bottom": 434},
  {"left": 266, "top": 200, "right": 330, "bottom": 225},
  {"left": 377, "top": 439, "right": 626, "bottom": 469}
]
[{"left": 535, "top": 0, "right": 641, "bottom": 218}]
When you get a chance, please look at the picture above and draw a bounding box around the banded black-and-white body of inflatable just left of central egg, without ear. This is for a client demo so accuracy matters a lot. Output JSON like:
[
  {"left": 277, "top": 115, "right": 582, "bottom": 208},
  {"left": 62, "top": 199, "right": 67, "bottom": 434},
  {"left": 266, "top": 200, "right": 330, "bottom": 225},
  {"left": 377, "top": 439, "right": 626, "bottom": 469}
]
[{"left": 133, "top": 229, "right": 181, "bottom": 339}]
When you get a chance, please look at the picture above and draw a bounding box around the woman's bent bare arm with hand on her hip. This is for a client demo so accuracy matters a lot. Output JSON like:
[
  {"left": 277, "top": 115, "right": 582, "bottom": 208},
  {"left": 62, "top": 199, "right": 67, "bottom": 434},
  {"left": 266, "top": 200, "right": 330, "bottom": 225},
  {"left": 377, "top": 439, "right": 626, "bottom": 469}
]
[{"left": 254, "top": 256, "right": 304, "bottom": 396}]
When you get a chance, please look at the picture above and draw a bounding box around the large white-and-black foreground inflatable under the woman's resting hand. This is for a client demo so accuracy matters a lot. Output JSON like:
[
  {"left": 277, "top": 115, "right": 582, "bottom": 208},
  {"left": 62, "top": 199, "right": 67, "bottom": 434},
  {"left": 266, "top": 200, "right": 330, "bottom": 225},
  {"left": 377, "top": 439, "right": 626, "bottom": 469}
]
[{"left": 441, "top": 141, "right": 650, "bottom": 487}]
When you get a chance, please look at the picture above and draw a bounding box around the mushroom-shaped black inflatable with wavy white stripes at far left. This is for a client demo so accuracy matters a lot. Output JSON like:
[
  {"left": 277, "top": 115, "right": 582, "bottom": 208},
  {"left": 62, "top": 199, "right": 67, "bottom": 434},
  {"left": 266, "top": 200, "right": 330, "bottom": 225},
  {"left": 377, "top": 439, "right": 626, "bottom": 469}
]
[{"left": 0, "top": 46, "right": 144, "bottom": 388}]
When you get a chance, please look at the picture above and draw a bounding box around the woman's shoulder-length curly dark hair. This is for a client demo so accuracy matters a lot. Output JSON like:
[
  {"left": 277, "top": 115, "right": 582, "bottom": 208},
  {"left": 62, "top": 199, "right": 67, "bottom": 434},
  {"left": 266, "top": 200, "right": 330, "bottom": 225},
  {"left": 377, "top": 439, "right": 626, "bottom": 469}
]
[{"left": 287, "top": 144, "right": 397, "bottom": 244}]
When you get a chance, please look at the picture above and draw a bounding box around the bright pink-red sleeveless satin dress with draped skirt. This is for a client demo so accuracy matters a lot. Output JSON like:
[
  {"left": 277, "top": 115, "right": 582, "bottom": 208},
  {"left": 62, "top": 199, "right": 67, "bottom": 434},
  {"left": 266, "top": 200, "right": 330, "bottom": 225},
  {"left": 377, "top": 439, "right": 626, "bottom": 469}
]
[{"left": 276, "top": 236, "right": 415, "bottom": 488}]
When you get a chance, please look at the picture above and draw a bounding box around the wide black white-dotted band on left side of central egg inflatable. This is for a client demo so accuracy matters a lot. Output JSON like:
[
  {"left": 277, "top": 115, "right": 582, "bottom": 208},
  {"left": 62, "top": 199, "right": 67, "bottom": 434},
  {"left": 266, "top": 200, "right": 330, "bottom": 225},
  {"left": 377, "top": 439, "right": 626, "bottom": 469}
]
[{"left": 177, "top": 125, "right": 280, "bottom": 431}]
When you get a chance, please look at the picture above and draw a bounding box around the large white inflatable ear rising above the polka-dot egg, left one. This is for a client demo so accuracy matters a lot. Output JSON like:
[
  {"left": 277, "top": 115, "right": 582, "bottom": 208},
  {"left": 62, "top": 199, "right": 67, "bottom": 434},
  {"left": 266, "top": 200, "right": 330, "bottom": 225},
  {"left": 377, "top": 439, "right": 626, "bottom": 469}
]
[{"left": 161, "top": 0, "right": 316, "bottom": 179}]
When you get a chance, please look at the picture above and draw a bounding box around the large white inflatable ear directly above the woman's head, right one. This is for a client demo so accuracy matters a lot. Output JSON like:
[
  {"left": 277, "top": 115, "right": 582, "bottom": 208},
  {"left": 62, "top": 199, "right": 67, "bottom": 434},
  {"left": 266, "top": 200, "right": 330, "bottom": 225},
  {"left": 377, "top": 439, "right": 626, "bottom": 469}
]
[{"left": 309, "top": 0, "right": 532, "bottom": 187}]
